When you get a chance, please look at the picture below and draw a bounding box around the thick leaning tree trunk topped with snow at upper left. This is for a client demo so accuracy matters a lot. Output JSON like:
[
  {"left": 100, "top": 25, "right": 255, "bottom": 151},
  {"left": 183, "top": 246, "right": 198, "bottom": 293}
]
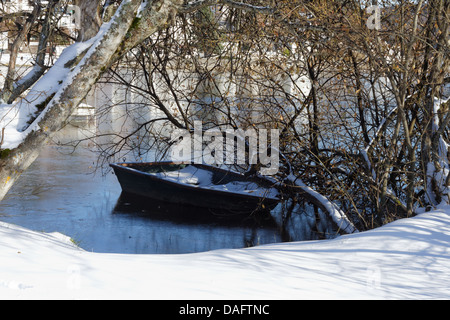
[{"left": 0, "top": 0, "right": 181, "bottom": 199}]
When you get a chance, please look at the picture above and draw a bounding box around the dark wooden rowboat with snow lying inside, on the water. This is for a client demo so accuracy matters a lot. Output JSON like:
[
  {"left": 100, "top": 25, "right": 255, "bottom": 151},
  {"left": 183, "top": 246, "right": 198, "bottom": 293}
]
[{"left": 110, "top": 162, "right": 280, "bottom": 213}]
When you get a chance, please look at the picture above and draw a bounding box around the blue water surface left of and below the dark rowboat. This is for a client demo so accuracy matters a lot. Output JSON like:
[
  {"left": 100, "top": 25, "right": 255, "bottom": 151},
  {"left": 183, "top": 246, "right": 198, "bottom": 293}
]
[{"left": 0, "top": 127, "right": 281, "bottom": 254}]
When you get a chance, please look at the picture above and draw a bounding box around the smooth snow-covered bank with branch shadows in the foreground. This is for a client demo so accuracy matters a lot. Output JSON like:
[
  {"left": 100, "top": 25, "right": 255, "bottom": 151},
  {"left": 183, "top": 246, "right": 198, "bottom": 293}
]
[{"left": 0, "top": 206, "right": 450, "bottom": 299}]
